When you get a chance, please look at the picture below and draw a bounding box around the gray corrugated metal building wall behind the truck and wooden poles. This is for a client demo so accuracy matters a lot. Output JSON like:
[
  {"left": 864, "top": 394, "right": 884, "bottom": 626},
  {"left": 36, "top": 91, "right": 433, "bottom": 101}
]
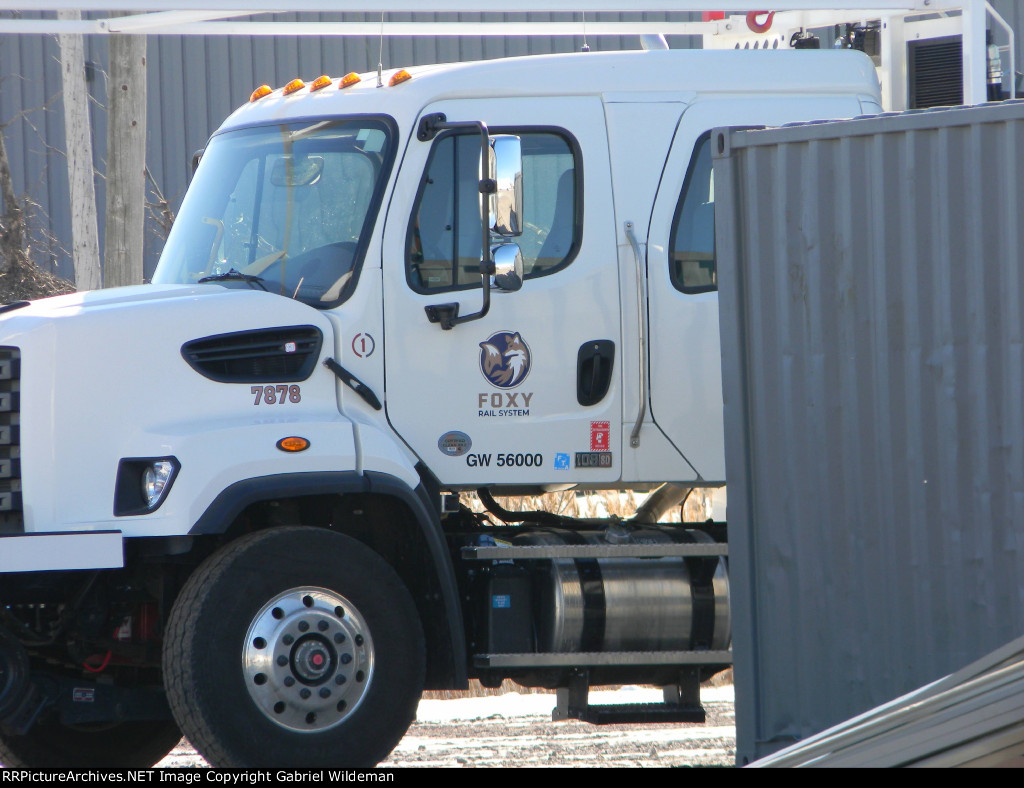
[{"left": 0, "top": 13, "right": 692, "bottom": 278}]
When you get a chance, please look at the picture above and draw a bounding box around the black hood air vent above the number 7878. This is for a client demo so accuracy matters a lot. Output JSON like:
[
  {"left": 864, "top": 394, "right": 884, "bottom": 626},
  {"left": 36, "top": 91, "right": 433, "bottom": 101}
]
[{"left": 181, "top": 325, "right": 324, "bottom": 383}]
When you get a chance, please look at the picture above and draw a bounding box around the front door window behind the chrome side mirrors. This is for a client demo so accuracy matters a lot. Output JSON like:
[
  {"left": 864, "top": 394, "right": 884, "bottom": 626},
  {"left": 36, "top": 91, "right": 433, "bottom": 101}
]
[{"left": 406, "top": 132, "right": 580, "bottom": 293}]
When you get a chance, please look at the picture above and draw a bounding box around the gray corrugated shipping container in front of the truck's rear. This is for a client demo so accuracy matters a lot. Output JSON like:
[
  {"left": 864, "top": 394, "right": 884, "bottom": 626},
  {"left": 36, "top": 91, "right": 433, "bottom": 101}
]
[{"left": 713, "top": 96, "right": 1024, "bottom": 763}]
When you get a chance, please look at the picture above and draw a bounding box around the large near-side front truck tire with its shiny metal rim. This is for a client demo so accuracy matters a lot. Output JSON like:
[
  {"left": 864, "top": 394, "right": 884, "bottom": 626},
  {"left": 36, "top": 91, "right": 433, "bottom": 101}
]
[{"left": 164, "top": 527, "right": 425, "bottom": 768}]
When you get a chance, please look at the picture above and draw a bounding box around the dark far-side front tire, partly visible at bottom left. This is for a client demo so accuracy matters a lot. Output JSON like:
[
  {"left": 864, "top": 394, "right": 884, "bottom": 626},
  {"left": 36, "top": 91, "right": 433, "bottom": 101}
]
[{"left": 0, "top": 719, "right": 181, "bottom": 769}]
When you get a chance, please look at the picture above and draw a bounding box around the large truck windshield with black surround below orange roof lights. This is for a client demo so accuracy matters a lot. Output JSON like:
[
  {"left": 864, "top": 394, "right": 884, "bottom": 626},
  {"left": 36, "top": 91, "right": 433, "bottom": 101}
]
[{"left": 153, "top": 118, "right": 392, "bottom": 307}]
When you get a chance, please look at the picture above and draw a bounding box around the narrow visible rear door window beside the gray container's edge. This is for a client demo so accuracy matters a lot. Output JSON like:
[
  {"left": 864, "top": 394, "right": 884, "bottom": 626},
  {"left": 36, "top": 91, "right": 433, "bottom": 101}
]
[{"left": 669, "top": 134, "right": 718, "bottom": 293}]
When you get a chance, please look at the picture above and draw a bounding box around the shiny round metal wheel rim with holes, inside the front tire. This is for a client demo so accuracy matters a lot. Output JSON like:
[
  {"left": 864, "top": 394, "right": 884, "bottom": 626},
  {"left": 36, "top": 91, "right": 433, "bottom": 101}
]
[{"left": 242, "top": 586, "right": 374, "bottom": 733}]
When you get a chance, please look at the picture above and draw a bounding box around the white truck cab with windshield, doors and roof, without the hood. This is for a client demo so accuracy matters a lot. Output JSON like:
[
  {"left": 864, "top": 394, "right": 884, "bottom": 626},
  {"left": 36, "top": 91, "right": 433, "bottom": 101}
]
[{"left": 154, "top": 51, "right": 880, "bottom": 493}]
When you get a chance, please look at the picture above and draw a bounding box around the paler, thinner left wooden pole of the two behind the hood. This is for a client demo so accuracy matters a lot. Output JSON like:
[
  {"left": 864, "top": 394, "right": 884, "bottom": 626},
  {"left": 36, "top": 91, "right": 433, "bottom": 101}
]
[{"left": 57, "top": 10, "right": 100, "bottom": 290}]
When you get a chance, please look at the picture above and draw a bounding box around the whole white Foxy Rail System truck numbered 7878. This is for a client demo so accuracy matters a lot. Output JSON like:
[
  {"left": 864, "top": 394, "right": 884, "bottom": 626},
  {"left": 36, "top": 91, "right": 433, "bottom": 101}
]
[{"left": 0, "top": 3, "right": 1007, "bottom": 767}]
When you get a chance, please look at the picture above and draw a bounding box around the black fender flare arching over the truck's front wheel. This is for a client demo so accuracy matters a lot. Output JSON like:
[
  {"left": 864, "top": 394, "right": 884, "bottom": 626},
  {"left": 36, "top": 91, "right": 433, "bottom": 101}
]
[{"left": 188, "top": 471, "right": 469, "bottom": 689}]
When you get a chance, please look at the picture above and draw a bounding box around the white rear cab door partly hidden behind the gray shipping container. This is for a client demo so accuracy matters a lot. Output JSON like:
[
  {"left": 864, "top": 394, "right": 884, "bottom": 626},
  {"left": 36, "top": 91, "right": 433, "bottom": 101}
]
[{"left": 647, "top": 95, "right": 860, "bottom": 484}]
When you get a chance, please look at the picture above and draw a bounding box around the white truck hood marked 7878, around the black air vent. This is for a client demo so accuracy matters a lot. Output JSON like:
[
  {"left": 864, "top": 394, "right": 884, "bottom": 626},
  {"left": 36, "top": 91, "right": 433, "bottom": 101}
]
[{"left": 0, "top": 284, "right": 342, "bottom": 531}]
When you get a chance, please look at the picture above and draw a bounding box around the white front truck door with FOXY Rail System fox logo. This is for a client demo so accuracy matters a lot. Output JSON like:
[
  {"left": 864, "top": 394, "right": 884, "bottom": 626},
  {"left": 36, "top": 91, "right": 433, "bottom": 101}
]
[{"left": 383, "top": 97, "right": 622, "bottom": 487}]
